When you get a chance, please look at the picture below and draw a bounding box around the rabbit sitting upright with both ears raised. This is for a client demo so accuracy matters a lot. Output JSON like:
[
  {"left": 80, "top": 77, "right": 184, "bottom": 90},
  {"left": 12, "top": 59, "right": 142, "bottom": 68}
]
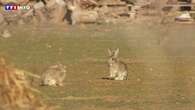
[{"left": 108, "top": 48, "right": 128, "bottom": 80}]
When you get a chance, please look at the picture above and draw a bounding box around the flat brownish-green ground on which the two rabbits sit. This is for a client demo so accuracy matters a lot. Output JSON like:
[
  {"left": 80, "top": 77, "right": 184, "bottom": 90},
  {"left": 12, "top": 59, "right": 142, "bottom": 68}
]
[{"left": 0, "top": 23, "right": 195, "bottom": 110}]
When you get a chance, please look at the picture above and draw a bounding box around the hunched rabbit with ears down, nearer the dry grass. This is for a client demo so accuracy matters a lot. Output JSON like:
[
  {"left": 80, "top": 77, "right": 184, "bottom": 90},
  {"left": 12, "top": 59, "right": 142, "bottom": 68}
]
[{"left": 41, "top": 64, "right": 66, "bottom": 86}]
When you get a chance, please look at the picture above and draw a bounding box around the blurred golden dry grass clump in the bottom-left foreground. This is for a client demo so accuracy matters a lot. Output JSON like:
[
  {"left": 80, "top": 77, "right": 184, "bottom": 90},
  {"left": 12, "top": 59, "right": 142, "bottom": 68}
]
[{"left": 0, "top": 58, "right": 51, "bottom": 110}]
